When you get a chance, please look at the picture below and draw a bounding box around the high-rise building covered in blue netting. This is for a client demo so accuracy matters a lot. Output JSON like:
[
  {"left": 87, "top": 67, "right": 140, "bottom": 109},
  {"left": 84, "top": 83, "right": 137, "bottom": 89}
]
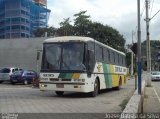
[{"left": 0, "top": 0, "right": 50, "bottom": 39}]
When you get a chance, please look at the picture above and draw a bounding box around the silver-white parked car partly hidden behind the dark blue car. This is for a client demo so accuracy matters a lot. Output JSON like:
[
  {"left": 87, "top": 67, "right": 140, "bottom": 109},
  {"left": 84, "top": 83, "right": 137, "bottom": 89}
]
[{"left": 0, "top": 67, "right": 22, "bottom": 83}]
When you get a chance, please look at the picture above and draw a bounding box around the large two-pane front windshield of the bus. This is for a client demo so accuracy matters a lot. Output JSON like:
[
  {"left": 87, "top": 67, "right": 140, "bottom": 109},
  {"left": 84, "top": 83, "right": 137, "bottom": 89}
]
[{"left": 42, "top": 43, "right": 86, "bottom": 70}]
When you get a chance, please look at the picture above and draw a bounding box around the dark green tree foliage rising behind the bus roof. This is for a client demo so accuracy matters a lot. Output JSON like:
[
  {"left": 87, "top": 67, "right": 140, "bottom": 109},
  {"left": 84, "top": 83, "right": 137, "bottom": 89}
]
[{"left": 35, "top": 11, "right": 125, "bottom": 52}]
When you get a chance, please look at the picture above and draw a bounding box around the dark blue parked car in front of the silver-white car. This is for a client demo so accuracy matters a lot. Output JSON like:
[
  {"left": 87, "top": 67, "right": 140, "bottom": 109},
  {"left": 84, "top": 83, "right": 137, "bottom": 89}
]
[{"left": 10, "top": 70, "right": 38, "bottom": 85}]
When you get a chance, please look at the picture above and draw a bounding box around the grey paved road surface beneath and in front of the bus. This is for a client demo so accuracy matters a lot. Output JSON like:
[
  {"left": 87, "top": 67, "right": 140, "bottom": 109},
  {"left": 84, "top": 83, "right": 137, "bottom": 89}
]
[{"left": 0, "top": 79, "right": 134, "bottom": 118}]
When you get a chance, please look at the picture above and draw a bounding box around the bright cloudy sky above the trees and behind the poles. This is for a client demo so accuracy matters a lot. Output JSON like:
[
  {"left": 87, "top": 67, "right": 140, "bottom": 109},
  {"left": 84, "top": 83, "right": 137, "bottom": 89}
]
[{"left": 47, "top": 0, "right": 160, "bottom": 44}]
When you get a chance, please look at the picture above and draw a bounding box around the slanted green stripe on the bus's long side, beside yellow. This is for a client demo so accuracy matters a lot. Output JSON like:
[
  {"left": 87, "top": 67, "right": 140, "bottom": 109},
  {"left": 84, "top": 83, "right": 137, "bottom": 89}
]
[{"left": 103, "top": 64, "right": 112, "bottom": 88}]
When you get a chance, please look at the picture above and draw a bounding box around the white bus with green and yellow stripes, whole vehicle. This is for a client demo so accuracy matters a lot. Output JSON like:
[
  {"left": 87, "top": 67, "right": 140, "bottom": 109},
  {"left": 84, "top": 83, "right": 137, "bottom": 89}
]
[{"left": 39, "top": 36, "right": 127, "bottom": 97}]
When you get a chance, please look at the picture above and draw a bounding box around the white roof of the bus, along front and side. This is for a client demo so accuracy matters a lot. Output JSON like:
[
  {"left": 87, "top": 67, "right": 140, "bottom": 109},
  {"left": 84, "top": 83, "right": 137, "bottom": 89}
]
[{"left": 44, "top": 36, "right": 125, "bottom": 55}]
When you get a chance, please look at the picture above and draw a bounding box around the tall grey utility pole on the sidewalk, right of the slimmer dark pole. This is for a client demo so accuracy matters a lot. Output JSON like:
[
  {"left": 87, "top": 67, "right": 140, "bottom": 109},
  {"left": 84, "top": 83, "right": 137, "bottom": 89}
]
[{"left": 145, "top": 0, "right": 151, "bottom": 86}]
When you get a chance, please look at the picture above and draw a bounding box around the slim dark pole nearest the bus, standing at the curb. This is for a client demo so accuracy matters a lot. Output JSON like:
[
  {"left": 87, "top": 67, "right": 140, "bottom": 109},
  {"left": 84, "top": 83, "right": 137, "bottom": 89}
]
[{"left": 137, "top": 0, "right": 142, "bottom": 95}]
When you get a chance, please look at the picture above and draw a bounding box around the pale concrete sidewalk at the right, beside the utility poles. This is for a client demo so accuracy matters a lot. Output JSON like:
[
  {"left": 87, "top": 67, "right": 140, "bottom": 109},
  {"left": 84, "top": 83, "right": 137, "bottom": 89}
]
[{"left": 143, "top": 85, "right": 160, "bottom": 113}]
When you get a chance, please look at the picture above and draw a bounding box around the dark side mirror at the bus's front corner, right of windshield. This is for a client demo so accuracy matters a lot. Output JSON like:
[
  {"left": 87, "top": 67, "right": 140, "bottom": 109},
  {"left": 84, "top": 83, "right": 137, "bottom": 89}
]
[{"left": 88, "top": 50, "right": 95, "bottom": 74}]
